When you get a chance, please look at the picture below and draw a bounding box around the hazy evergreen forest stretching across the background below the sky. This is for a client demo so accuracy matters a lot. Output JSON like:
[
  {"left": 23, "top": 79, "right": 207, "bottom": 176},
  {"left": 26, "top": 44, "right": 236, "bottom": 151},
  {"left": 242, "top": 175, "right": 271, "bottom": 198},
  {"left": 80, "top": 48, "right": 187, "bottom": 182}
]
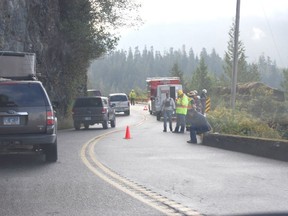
[{"left": 87, "top": 45, "right": 283, "bottom": 94}]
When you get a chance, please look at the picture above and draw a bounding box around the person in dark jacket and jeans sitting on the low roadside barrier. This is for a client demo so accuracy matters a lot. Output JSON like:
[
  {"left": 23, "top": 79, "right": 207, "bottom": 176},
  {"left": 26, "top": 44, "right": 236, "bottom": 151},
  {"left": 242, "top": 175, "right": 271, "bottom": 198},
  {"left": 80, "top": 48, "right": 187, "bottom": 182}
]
[{"left": 187, "top": 109, "right": 212, "bottom": 144}]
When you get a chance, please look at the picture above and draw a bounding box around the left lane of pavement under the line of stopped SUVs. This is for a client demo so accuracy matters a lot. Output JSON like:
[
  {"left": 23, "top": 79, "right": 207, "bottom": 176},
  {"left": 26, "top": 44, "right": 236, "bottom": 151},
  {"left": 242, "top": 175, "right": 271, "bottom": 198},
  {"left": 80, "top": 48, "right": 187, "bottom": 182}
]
[{"left": 0, "top": 104, "right": 165, "bottom": 216}]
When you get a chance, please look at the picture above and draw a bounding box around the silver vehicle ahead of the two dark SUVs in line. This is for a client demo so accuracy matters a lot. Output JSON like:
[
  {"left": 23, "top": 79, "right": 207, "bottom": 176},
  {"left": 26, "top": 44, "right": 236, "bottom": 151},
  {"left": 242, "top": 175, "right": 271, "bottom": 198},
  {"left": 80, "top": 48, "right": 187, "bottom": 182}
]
[{"left": 109, "top": 93, "right": 130, "bottom": 115}]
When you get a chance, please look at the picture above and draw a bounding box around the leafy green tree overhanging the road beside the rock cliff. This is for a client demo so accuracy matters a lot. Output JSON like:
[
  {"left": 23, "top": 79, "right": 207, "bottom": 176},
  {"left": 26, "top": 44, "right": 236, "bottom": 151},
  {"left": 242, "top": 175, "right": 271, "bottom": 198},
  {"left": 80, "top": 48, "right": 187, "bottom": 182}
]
[{"left": 53, "top": 0, "right": 140, "bottom": 115}]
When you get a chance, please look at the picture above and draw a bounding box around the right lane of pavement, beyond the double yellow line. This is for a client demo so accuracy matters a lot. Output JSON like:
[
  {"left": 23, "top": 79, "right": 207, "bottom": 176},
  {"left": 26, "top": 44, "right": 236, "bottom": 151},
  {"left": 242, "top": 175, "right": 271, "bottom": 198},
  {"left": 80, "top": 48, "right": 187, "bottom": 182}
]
[{"left": 95, "top": 104, "right": 288, "bottom": 215}]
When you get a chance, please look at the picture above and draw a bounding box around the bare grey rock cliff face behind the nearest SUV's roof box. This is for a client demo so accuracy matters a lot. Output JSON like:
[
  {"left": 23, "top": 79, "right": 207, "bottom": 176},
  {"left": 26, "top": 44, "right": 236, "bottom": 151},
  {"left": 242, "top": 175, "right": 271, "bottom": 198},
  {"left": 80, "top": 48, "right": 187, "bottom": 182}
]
[{"left": 0, "top": 0, "right": 77, "bottom": 116}]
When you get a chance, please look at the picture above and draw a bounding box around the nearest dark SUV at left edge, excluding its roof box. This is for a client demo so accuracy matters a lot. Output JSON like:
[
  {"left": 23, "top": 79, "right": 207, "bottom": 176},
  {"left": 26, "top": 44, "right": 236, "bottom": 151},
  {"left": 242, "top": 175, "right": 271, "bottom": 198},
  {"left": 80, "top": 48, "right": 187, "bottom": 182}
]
[{"left": 0, "top": 78, "right": 58, "bottom": 162}]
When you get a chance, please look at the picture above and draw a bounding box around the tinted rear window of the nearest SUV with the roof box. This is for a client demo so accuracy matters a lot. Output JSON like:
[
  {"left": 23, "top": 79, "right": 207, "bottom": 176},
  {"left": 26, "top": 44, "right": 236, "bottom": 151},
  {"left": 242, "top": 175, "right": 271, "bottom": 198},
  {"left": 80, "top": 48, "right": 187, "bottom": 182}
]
[{"left": 0, "top": 83, "right": 45, "bottom": 107}]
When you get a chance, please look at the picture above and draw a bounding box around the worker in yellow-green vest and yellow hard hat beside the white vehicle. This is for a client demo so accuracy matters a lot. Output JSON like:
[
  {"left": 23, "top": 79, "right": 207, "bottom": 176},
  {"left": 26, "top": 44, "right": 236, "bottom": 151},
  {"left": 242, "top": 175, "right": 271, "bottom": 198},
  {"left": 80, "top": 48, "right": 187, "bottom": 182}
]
[{"left": 173, "top": 90, "right": 189, "bottom": 133}]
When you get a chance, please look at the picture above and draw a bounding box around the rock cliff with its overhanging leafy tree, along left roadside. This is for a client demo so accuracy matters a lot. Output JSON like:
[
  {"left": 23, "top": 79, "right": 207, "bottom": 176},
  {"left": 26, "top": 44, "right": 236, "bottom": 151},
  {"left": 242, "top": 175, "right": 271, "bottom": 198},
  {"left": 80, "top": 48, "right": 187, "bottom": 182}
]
[{"left": 0, "top": 0, "right": 140, "bottom": 116}]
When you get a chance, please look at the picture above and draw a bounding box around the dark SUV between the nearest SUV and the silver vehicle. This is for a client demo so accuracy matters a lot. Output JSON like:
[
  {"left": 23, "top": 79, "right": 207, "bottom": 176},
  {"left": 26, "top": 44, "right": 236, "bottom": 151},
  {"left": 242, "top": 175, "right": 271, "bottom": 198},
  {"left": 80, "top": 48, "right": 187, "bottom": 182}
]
[{"left": 72, "top": 96, "right": 116, "bottom": 130}]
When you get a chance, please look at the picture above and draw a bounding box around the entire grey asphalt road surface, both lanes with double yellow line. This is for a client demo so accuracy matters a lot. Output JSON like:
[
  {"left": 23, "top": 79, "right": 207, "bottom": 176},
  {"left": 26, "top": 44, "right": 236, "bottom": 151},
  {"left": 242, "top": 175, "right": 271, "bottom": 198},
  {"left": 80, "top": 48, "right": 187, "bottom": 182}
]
[{"left": 0, "top": 105, "right": 288, "bottom": 216}]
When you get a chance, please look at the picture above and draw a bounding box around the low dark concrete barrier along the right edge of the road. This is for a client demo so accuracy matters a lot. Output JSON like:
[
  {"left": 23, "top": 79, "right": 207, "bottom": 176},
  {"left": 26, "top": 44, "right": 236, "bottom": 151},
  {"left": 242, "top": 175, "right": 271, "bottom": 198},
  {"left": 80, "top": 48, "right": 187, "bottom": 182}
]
[{"left": 202, "top": 133, "right": 288, "bottom": 161}]
